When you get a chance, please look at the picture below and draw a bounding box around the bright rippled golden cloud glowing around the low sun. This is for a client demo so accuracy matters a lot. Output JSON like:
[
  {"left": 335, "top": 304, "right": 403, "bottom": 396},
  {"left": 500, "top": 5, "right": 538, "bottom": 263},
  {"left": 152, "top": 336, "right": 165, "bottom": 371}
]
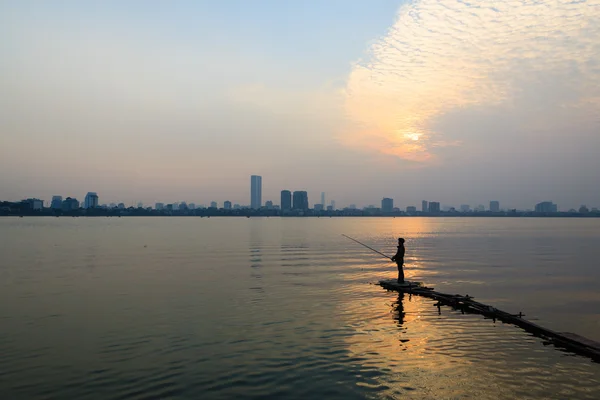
[{"left": 342, "top": 0, "right": 600, "bottom": 162}]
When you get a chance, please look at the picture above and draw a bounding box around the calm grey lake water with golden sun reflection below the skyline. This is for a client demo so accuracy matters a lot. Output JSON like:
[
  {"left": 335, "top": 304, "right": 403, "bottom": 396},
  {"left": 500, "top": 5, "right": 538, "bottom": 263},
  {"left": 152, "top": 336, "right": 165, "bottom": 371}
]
[{"left": 0, "top": 218, "right": 600, "bottom": 399}]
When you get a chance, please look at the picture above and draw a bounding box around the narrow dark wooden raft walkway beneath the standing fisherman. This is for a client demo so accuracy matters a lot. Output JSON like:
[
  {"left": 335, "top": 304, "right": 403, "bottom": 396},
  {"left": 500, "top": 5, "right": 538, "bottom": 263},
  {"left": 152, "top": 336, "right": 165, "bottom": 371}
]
[{"left": 379, "top": 279, "right": 600, "bottom": 362}]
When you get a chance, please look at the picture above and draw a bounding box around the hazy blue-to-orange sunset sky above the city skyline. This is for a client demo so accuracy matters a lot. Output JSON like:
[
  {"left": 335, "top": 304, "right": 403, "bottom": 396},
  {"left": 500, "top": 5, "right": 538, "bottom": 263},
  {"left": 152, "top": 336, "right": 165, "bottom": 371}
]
[{"left": 0, "top": 0, "right": 600, "bottom": 209}]
